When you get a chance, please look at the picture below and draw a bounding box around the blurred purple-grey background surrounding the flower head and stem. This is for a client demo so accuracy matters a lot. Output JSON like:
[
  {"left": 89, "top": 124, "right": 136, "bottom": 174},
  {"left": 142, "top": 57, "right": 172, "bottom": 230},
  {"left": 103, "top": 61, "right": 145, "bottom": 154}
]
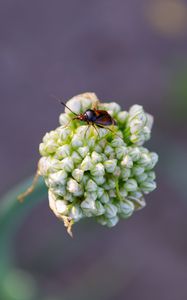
[{"left": 0, "top": 0, "right": 187, "bottom": 300}]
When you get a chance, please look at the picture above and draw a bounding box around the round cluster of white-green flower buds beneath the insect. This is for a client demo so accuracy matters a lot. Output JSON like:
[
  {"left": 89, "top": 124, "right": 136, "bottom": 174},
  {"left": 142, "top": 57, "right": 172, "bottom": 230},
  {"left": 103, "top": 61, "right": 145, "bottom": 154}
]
[{"left": 35, "top": 93, "right": 158, "bottom": 233}]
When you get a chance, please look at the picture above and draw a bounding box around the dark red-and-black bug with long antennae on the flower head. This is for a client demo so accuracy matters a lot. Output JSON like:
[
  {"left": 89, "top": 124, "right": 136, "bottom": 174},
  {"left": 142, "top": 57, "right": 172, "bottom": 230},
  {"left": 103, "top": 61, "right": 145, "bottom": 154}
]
[{"left": 60, "top": 101, "right": 117, "bottom": 132}]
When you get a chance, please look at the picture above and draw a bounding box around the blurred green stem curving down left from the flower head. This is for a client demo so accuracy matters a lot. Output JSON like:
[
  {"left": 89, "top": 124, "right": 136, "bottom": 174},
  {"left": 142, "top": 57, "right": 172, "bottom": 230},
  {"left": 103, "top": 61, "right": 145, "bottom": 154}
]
[{"left": 0, "top": 178, "right": 47, "bottom": 276}]
